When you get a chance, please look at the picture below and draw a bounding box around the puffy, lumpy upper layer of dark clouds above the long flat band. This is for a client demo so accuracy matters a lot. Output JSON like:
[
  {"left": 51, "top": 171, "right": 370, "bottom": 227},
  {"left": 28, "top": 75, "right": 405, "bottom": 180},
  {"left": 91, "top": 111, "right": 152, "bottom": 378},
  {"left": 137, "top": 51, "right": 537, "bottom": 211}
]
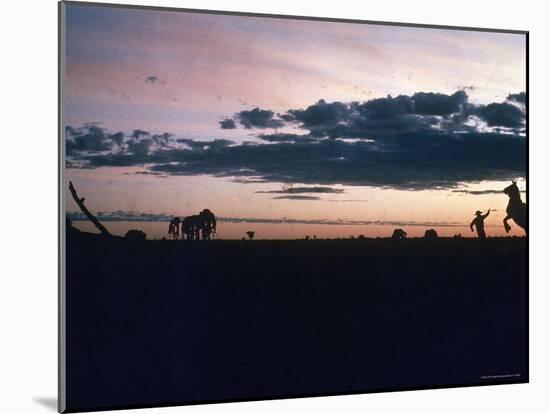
[{"left": 220, "top": 90, "right": 525, "bottom": 138}]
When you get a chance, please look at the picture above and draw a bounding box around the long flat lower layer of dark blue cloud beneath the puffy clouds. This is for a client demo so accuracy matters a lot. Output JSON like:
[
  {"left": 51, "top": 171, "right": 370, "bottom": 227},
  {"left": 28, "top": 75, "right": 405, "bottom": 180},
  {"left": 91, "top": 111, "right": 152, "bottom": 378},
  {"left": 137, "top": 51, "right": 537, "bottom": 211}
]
[{"left": 89, "top": 133, "right": 526, "bottom": 189}]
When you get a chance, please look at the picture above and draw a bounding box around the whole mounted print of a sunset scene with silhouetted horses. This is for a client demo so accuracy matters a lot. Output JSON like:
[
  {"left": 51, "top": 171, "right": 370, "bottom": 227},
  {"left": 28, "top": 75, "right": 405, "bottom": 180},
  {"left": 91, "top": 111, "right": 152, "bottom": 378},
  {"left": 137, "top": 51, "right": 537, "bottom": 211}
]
[{"left": 60, "top": 2, "right": 528, "bottom": 412}]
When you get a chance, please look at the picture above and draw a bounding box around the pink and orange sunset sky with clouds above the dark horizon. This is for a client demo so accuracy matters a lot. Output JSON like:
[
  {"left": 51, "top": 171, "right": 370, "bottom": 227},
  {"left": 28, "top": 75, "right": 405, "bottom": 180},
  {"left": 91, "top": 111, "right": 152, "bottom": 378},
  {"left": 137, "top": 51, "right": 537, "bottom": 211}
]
[{"left": 64, "top": 4, "right": 527, "bottom": 239}]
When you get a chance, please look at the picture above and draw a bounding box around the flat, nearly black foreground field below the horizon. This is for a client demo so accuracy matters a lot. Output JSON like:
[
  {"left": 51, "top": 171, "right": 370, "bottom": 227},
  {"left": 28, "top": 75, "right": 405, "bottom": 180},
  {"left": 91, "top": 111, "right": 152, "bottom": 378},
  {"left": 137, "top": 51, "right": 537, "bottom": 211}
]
[{"left": 67, "top": 234, "right": 527, "bottom": 410}]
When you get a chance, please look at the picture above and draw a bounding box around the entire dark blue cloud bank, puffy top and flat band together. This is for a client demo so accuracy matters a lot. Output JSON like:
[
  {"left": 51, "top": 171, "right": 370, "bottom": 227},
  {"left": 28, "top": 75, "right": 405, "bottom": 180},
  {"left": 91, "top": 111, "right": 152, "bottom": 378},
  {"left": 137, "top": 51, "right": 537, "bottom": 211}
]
[{"left": 67, "top": 91, "right": 527, "bottom": 191}]
